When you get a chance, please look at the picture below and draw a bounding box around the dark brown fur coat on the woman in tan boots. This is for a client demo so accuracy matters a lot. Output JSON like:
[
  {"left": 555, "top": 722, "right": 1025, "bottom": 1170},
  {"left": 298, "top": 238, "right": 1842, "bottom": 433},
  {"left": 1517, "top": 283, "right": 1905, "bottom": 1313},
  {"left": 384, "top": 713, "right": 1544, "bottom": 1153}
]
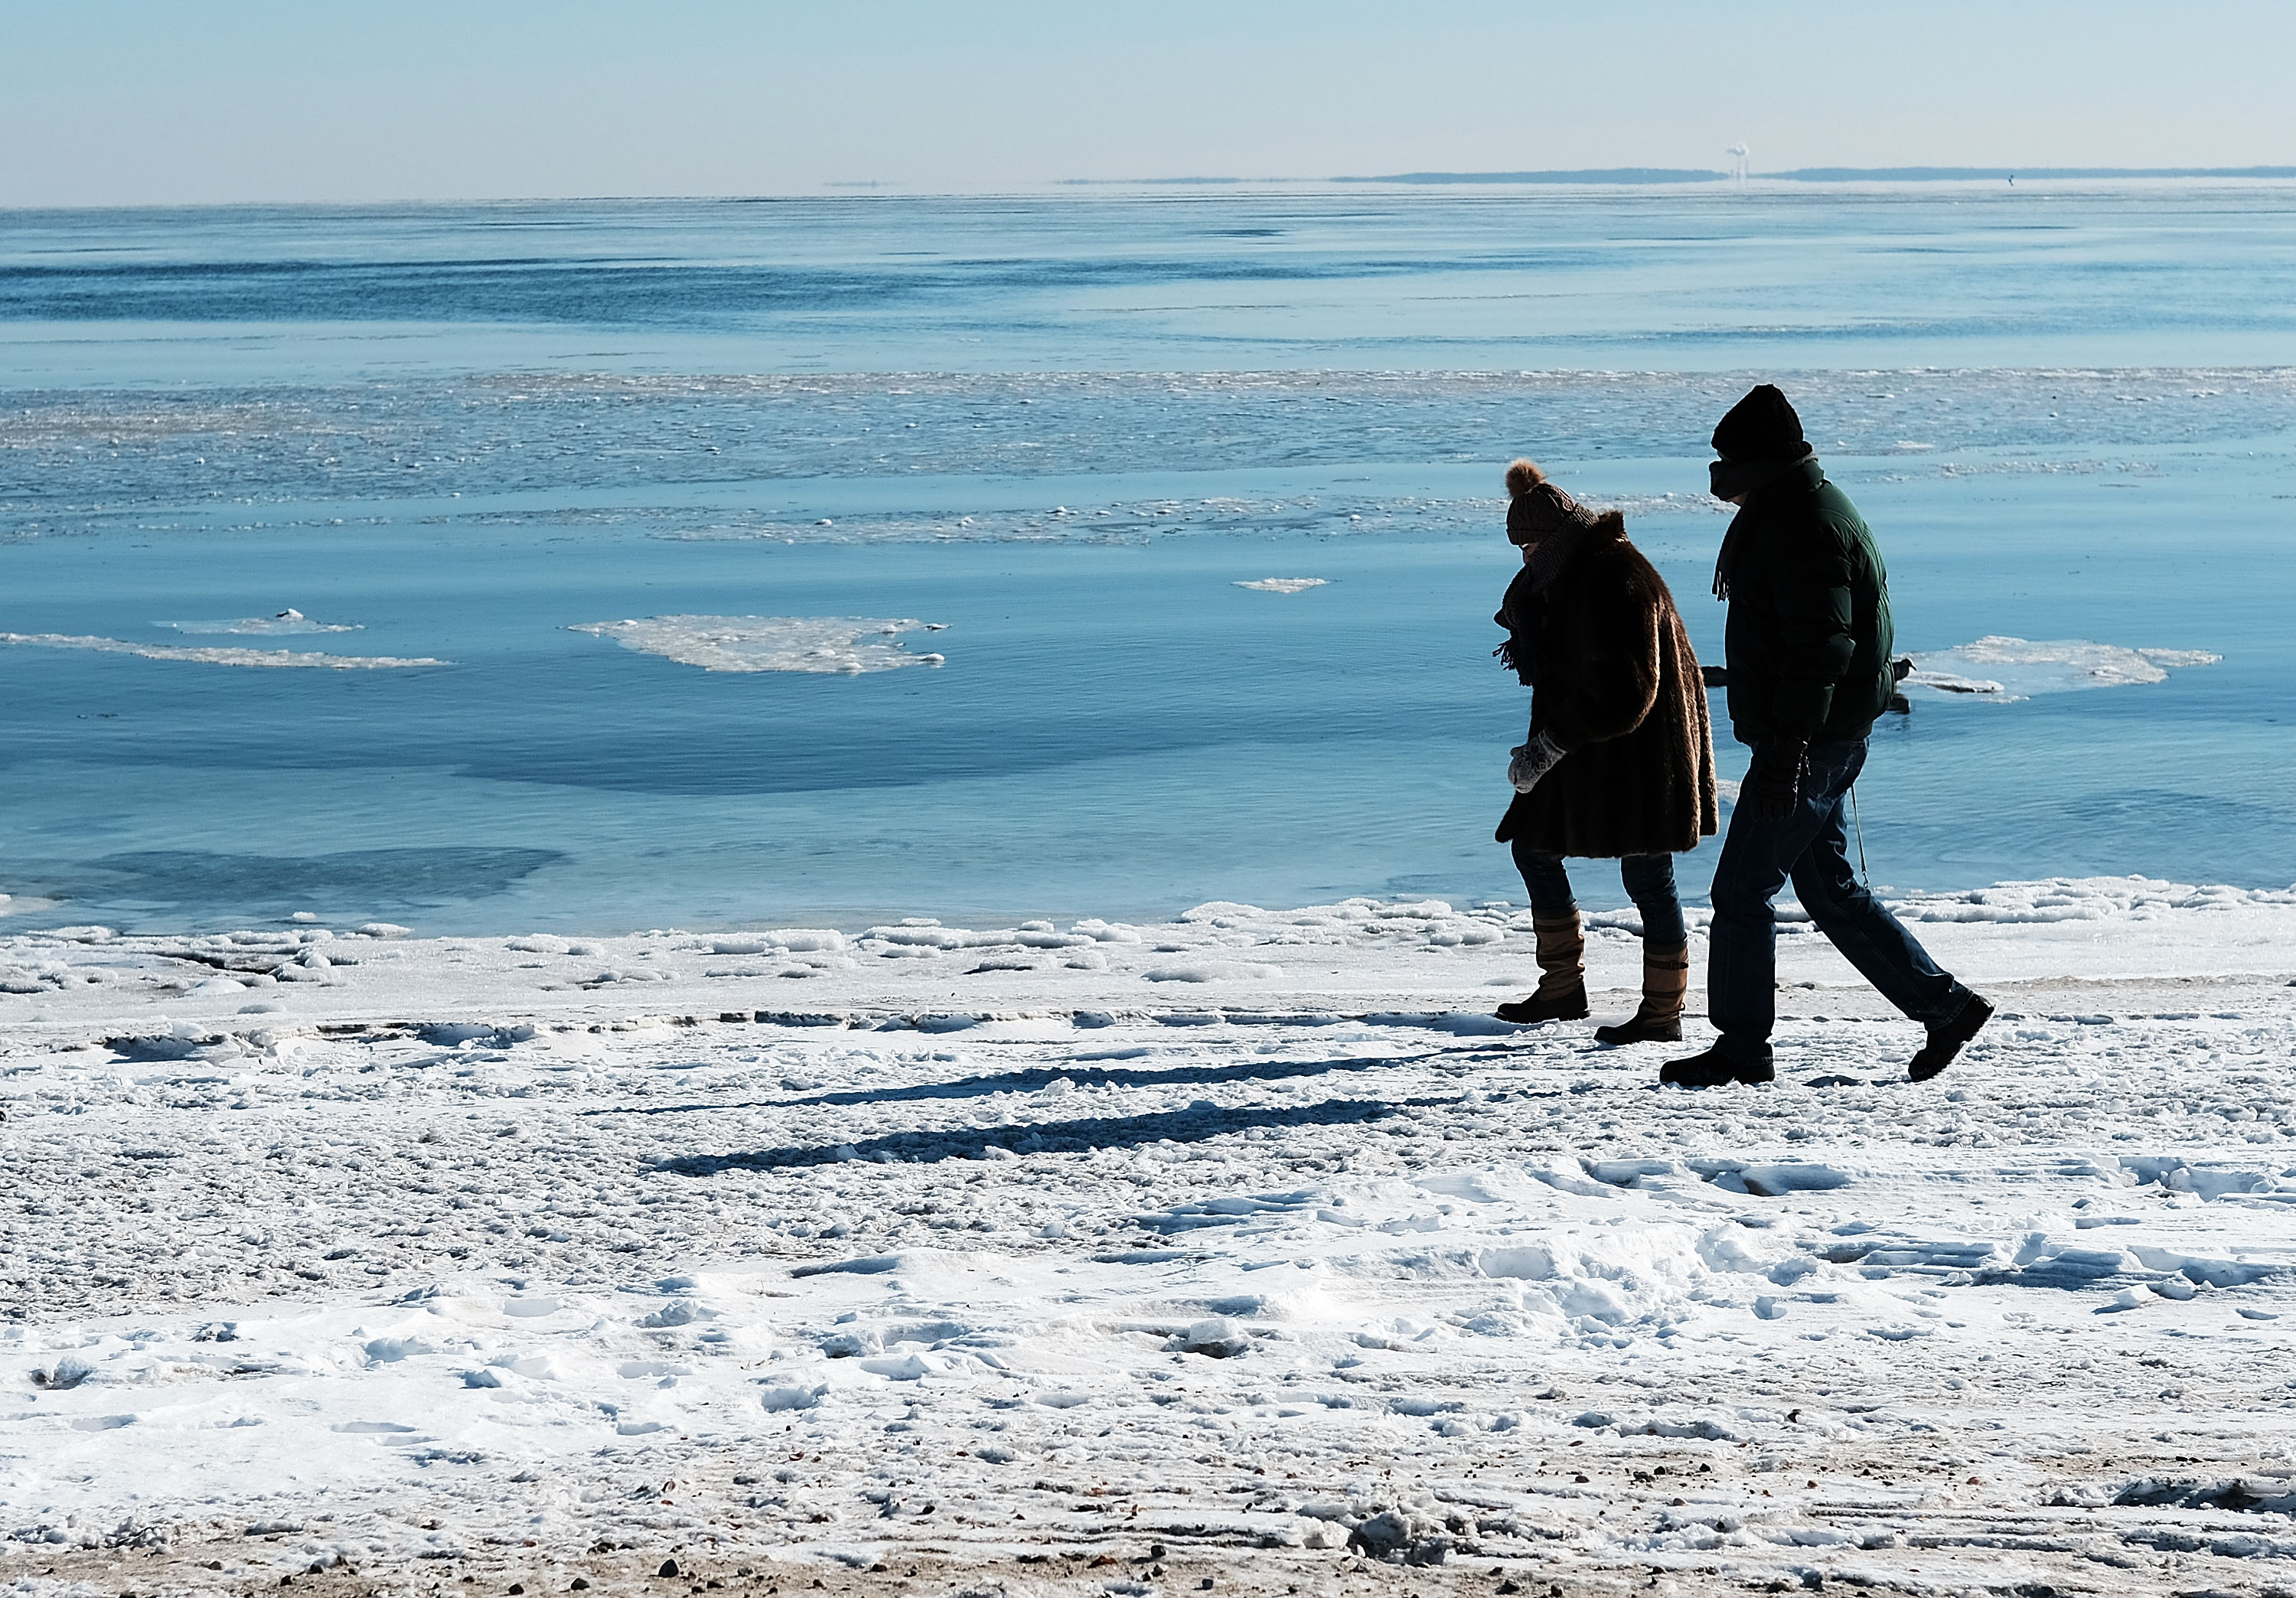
[{"left": 1499, "top": 512, "right": 1720, "bottom": 859}]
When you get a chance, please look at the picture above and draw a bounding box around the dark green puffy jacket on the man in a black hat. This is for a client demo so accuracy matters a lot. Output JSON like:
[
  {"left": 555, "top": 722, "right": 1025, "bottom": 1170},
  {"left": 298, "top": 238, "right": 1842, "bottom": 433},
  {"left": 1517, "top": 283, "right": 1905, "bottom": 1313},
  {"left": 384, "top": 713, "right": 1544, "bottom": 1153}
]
[{"left": 1722, "top": 459, "right": 1896, "bottom": 744}]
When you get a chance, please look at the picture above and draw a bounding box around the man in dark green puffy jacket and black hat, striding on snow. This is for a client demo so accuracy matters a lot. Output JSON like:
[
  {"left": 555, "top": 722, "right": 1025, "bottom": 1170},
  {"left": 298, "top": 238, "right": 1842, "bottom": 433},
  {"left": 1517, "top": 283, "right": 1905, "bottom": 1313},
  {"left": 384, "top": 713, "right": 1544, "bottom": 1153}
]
[{"left": 1660, "top": 383, "right": 1993, "bottom": 1088}]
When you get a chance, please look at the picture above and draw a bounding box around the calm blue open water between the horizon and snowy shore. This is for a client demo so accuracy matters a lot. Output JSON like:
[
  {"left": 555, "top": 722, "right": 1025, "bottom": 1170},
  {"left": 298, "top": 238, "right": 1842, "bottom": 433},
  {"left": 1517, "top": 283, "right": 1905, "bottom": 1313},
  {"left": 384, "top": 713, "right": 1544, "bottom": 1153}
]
[{"left": 0, "top": 184, "right": 2296, "bottom": 932}]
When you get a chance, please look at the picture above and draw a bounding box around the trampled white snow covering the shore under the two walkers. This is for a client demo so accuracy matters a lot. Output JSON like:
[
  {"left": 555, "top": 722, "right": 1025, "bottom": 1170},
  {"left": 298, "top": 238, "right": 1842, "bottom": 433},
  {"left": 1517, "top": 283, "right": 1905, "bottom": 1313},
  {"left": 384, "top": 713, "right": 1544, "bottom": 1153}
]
[{"left": 0, "top": 879, "right": 2296, "bottom": 1593}]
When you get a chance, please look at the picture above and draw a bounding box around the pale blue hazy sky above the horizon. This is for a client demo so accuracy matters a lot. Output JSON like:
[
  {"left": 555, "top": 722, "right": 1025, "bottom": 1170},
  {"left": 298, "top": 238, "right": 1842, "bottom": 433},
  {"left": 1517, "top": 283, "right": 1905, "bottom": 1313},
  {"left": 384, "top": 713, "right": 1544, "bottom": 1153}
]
[{"left": 0, "top": 0, "right": 2296, "bottom": 207}]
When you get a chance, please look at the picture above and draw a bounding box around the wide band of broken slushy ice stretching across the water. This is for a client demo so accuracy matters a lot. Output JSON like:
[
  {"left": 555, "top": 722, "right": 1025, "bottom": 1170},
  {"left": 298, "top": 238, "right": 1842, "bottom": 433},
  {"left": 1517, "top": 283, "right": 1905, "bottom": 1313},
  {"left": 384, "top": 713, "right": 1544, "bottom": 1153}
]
[{"left": 18, "top": 367, "right": 2296, "bottom": 530}]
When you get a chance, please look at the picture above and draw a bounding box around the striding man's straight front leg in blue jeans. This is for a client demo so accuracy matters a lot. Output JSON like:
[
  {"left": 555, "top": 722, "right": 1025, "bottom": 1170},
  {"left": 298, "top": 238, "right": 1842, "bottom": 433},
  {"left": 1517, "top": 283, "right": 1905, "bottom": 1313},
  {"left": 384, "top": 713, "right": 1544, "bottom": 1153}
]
[{"left": 1706, "top": 744, "right": 1848, "bottom": 1065}]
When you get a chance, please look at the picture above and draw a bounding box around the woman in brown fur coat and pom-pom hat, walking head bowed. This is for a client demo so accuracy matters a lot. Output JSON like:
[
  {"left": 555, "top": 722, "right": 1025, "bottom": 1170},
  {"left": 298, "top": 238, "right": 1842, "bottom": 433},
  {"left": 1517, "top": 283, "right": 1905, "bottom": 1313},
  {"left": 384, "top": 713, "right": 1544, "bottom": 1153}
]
[{"left": 1492, "top": 461, "right": 1720, "bottom": 1042}]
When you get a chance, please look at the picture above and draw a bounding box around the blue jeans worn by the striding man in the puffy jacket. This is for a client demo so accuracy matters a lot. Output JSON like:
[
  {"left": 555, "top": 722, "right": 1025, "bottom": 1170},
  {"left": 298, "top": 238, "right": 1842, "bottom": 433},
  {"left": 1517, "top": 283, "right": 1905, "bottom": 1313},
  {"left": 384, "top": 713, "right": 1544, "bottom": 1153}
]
[{"left": 1706, "top": 739, "right": 1970, "bottom": 1065}]
